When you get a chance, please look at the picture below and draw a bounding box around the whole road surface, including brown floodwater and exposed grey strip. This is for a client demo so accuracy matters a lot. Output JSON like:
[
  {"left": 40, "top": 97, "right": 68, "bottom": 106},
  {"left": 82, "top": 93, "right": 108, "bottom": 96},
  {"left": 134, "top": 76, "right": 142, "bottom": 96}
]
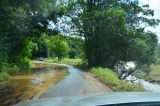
[{"left": 0, "top": 61, "right": 112, "bottom": 106}]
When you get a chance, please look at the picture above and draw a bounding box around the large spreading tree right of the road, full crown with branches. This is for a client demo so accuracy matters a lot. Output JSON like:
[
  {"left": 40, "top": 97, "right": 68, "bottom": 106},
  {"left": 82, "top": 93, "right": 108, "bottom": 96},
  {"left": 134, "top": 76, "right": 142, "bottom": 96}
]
[{"left": 59, "top": 0, "right": 159, "bottom": 68}]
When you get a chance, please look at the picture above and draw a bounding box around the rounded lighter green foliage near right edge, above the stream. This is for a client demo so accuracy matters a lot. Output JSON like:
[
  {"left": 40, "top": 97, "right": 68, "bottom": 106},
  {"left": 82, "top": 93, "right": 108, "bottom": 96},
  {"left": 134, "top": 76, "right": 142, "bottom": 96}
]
[{"left": 130, "top": 32, "right": 158, "bottom": 66}]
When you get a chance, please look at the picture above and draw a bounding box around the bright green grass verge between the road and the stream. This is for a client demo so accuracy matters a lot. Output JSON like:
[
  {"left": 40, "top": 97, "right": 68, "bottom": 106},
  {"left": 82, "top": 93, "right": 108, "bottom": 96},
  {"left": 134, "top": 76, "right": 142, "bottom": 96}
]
[{"left": 91, "top": 68, "right": 146, "bottom": 92}]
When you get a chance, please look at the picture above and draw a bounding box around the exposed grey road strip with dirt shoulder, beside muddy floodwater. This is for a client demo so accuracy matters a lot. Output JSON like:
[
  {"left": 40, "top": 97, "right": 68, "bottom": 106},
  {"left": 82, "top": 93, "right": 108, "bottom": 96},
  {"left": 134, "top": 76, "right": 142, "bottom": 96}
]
[{"left": 39, "top": 63, "right": 112, "bottom": 98}]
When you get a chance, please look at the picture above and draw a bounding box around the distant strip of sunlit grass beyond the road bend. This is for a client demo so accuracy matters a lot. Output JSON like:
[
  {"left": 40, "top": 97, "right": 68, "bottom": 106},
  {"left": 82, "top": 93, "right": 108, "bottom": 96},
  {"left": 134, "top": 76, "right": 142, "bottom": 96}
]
[{"left": 45, "top": 58, "right": 82, "bottom": 66}]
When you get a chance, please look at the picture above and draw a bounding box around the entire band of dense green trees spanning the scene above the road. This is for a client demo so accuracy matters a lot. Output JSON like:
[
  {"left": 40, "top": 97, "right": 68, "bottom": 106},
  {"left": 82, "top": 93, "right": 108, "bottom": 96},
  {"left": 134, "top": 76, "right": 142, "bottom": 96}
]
[{"left": 0, "top": 0, "right": 160, "bottom": 85}]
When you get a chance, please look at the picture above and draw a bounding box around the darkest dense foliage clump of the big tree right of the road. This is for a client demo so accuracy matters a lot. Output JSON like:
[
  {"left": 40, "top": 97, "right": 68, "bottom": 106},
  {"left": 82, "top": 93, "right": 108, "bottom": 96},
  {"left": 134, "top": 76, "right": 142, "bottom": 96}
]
[{"left": 84, "top": 8, "right": 125, "bottom": 67}]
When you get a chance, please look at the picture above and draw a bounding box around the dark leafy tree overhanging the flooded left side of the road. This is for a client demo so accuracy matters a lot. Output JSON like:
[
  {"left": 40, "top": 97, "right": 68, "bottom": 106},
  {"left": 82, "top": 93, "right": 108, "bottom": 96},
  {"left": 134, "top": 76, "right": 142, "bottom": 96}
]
[{"left": 0, "top": 0, "right": 56, "bottom": 66}]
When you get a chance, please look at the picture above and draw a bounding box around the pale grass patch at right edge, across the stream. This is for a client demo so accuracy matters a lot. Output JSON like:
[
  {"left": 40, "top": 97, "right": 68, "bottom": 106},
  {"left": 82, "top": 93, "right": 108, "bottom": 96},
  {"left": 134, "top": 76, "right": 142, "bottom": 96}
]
[{"left": 149, "top": 65, "right": 160, "bottom": 81}]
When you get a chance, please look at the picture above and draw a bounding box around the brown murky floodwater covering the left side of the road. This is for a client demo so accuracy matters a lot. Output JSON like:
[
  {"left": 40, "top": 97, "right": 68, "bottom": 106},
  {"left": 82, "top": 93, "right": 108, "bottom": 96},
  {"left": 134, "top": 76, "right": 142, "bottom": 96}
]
[{"left": 0, "top": 63, "right": 68, "bottom": 106}]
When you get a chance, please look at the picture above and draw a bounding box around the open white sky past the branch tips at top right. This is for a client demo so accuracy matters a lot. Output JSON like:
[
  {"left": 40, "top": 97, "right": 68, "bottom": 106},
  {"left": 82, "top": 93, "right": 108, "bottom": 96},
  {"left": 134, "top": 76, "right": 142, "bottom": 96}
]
[{"left": 139, "top": 0, "right": 160, "bottom": 39}]
